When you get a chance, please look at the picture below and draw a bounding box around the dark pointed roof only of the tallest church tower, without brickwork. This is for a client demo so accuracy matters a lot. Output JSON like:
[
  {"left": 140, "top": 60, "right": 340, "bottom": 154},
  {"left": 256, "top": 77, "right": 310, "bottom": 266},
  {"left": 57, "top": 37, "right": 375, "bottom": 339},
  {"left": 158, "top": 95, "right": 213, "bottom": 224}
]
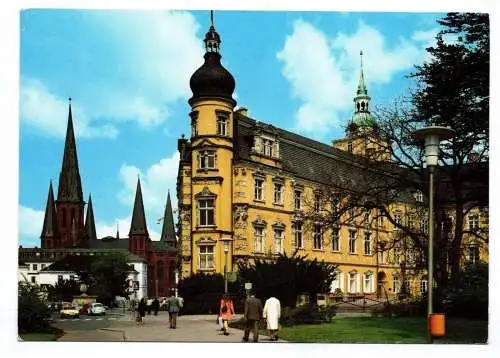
[{"left": 57, "top": 98, "right": 83, "bottom": 203}]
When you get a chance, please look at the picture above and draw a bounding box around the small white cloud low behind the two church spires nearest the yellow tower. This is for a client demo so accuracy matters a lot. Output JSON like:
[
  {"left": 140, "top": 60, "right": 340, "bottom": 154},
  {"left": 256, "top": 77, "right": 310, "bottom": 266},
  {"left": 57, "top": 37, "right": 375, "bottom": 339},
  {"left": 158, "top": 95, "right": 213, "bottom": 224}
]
[{"left": 118, "top": 152, "right": 179, "bottom": 220}]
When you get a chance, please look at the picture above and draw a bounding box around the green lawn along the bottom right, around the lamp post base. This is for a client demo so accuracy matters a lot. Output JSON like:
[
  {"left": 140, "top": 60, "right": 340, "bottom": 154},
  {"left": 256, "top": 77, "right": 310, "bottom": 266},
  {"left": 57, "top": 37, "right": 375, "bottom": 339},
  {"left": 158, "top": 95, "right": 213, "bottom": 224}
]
[{"left": 231, "top": 317, "right": 488, "bottom": 344}]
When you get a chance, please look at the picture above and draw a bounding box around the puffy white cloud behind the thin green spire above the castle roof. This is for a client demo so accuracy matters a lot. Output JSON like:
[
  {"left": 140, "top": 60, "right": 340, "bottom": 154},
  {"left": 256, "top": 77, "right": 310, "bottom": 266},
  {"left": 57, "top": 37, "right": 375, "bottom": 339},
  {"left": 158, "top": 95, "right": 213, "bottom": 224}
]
[{"left": 276, "top": 20, "right": 438, "bottom": 133}]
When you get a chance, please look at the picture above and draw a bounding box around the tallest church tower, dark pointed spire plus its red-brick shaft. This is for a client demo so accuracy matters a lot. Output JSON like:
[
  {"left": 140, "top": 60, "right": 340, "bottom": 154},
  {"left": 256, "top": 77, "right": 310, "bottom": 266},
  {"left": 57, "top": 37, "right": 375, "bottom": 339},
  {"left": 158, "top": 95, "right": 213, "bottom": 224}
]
[{"left": 56, "top": 98, "right": 85, "bottom": 248}]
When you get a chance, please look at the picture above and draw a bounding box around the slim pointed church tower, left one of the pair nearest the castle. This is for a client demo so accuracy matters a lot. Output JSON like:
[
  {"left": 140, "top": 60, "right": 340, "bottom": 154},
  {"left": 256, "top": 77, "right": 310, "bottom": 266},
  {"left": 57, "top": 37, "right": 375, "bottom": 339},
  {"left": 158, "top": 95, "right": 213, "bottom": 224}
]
[{"left": 128, "top": 178, "right": 150, "bottom": 259}]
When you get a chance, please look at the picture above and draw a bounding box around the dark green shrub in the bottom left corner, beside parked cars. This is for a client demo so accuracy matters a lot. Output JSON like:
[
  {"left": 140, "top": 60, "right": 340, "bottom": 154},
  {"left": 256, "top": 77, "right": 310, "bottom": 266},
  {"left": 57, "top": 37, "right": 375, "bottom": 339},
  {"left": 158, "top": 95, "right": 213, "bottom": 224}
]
[{"left": 17, "top": 282, "right": 51, "bottom": 333}]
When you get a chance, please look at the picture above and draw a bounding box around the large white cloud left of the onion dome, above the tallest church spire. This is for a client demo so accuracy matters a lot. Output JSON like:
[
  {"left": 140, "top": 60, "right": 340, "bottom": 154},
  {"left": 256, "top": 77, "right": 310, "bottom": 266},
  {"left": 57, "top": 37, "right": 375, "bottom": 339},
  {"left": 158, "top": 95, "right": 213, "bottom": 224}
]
[{"left": 20, "top": 11, "right": 203, "bottom": 138}]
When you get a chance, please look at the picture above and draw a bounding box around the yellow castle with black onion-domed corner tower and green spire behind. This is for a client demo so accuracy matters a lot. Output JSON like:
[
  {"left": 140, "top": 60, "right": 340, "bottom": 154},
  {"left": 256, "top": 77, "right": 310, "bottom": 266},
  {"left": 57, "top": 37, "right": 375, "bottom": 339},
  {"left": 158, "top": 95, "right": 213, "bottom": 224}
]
[{"left": 177, "top": 13, "right": 488, "bottom": 296}]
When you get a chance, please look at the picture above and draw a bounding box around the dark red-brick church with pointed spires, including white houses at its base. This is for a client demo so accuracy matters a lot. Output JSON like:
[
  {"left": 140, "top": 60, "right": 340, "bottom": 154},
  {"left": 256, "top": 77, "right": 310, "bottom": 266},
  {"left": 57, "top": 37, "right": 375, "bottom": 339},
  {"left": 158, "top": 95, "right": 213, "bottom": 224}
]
[{"left": 19, "top": 99, "right": 177, "bottom": 297}]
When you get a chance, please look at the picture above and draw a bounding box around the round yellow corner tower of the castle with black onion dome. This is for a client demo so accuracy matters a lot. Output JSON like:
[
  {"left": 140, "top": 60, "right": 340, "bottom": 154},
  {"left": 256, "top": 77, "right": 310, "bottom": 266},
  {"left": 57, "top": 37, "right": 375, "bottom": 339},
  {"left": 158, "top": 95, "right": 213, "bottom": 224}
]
[{"left": 186, "top": 11, "right": 236, "bottom": 272}]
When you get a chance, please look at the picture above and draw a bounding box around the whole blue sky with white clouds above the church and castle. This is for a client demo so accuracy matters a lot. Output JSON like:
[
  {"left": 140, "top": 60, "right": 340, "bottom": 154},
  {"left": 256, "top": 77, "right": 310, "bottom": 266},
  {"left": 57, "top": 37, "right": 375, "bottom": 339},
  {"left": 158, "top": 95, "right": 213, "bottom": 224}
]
[{"left": 19, "top": 9, "right": 454, "bottom": 246}]
